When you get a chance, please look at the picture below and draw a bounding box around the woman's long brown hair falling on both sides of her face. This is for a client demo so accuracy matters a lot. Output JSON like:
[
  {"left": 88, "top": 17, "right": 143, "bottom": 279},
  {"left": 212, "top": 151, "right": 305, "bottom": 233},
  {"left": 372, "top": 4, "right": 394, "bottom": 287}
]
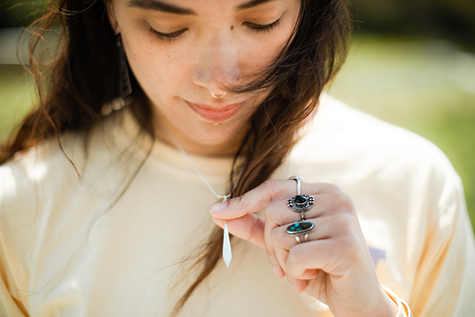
[{"left": 0, "top": 0, "right": 351, "bottom": 315}]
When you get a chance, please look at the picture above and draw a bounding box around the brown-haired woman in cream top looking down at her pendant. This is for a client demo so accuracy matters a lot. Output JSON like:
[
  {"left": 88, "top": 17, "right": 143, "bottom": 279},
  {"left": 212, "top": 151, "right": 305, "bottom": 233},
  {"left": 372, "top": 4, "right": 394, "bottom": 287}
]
[{"left": 0, "top": 0, "right": 475, "bottom": 316}]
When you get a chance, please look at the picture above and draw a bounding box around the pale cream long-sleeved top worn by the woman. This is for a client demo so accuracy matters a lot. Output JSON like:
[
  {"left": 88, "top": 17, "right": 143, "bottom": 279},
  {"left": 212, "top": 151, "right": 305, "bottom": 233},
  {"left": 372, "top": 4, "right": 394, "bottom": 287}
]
[{"left": 0, "top": 97, "right": 475, "bottom": 317}]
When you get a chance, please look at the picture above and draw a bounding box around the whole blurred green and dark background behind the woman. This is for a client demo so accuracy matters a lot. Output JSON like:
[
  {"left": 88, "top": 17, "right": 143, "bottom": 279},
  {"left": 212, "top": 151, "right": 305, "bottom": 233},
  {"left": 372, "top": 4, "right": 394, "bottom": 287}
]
[{"left": 0, "top": 0, "right": 475, "bottom": 232}]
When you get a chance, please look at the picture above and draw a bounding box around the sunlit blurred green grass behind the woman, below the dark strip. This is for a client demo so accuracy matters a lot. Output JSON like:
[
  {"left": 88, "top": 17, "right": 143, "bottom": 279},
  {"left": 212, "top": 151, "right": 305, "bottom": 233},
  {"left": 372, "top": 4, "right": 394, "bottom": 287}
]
[{"left": 0, "top": 37, "right": 475, "bottom": 232}]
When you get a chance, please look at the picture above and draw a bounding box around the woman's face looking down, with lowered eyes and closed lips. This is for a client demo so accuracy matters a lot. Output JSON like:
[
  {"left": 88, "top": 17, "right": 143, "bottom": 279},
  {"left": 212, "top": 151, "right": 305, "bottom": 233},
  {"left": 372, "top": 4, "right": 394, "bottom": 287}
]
[{"left": 110, "top": 0, "right": 300, "bottom": 156}]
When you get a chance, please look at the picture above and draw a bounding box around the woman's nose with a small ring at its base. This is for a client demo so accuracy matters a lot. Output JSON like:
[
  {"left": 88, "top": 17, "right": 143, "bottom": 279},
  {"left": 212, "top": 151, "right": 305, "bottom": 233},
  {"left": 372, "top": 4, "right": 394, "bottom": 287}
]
[{"left": 193, "top": 32, "right": 241, "bottom": 99}]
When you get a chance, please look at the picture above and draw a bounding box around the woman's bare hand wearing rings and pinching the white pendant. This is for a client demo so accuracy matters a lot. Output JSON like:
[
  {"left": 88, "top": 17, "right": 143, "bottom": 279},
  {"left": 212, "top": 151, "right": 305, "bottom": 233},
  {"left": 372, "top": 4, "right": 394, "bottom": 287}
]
[{"left": 210, "top": 180, "right": 397, "bottom": 316}]
